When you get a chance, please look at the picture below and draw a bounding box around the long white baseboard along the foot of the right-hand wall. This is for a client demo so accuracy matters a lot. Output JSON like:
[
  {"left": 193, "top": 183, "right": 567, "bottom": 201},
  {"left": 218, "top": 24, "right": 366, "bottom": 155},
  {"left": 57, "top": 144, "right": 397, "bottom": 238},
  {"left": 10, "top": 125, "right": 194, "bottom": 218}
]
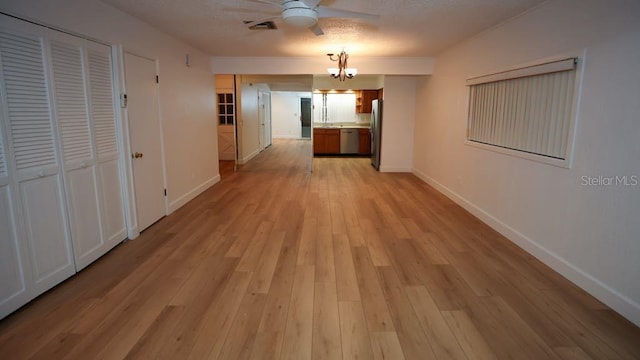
[{"left": 412, "top": 169, "right": 640, "bottom": 326}]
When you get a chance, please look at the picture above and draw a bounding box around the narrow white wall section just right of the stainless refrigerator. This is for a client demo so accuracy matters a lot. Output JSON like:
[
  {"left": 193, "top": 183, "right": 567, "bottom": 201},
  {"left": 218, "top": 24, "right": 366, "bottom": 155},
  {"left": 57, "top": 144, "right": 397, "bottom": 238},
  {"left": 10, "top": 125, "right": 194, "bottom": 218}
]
[{"left": 380, "top": 76, "right": 418, "bottom": 172}]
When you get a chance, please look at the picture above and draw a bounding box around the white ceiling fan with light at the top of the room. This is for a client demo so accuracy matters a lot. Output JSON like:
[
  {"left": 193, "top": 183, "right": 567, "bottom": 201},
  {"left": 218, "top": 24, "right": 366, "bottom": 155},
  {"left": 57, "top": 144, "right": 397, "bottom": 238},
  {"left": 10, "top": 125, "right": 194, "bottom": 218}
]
[{"left": 245, "top": 0, "right": 379, "bottom": 36}]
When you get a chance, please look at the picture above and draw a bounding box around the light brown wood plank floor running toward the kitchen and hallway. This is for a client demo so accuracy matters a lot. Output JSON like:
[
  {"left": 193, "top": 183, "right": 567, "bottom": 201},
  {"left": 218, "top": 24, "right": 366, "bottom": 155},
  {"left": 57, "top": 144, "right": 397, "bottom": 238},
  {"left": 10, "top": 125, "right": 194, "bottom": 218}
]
[{"left": 0, "top": 140, "right": 640, "bottom": 360}]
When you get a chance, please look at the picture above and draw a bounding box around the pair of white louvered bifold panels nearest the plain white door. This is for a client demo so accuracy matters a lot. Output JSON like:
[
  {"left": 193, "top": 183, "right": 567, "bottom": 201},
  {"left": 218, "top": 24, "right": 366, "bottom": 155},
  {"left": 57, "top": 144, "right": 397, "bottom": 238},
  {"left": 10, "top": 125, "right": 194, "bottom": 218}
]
[{"left": 50, "top": 32, "right": 126, "bottom": 270}]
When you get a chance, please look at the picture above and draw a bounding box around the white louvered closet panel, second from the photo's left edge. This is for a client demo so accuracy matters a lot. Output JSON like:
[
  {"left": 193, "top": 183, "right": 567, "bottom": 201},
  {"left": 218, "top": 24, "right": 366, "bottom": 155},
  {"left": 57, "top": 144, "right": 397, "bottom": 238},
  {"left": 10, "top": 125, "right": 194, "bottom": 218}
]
[{"left": 0, "top": 18, "right": 75, "bottom": 294}]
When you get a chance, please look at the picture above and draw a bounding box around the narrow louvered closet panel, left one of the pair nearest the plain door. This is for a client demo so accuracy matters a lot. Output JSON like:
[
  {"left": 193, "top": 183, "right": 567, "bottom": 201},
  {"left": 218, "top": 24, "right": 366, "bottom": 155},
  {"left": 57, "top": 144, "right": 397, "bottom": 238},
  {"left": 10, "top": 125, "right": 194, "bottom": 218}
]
[{"left": 49, "top": 33, "right": 104, "bottom": 270}]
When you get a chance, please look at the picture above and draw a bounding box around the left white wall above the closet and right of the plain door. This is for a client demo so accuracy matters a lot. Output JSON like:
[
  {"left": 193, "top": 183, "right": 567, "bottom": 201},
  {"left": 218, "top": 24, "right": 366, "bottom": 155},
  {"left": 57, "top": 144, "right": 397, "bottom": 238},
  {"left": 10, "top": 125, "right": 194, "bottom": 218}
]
[{"left": 0, "top": 0, "right": 219, "bottom": 217}]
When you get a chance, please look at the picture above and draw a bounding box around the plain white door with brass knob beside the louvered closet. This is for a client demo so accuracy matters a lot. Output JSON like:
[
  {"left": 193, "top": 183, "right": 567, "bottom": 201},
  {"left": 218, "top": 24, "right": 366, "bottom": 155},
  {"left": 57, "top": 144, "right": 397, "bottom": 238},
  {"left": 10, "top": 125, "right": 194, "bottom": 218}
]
[{"left": 124, "top": 53, "right": 166, "bottom": 231}]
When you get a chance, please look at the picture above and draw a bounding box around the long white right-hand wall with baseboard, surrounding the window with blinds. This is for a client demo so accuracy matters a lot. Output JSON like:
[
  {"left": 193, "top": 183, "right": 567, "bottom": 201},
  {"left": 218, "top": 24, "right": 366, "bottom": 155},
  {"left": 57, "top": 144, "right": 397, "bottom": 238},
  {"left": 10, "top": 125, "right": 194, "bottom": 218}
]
[{"left": 412, "top": 0, "right": 640, "bottom": 325}]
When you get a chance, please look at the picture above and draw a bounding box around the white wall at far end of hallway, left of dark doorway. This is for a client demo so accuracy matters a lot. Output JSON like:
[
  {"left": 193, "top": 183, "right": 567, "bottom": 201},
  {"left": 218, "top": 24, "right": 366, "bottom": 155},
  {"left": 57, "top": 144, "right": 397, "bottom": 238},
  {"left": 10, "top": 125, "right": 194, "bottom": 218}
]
[{"left": 271, "top": 91, "right": 311, "bottom": 139}]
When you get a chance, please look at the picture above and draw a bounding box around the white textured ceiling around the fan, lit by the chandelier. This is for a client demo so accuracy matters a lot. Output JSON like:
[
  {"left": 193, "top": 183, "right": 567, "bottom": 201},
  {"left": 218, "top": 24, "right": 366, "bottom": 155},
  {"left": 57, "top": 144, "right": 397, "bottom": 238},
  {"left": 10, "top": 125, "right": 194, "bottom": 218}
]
[{"left": 101, "top": 0, "right": 544, "bottom": 57}]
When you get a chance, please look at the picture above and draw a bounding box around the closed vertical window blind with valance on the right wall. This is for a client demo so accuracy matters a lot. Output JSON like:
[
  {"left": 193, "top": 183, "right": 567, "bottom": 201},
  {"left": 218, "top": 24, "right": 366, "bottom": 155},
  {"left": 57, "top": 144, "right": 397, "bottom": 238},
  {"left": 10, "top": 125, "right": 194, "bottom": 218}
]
[{"left": 467, "top": 58, "right": 576, "bottom": 160}]
